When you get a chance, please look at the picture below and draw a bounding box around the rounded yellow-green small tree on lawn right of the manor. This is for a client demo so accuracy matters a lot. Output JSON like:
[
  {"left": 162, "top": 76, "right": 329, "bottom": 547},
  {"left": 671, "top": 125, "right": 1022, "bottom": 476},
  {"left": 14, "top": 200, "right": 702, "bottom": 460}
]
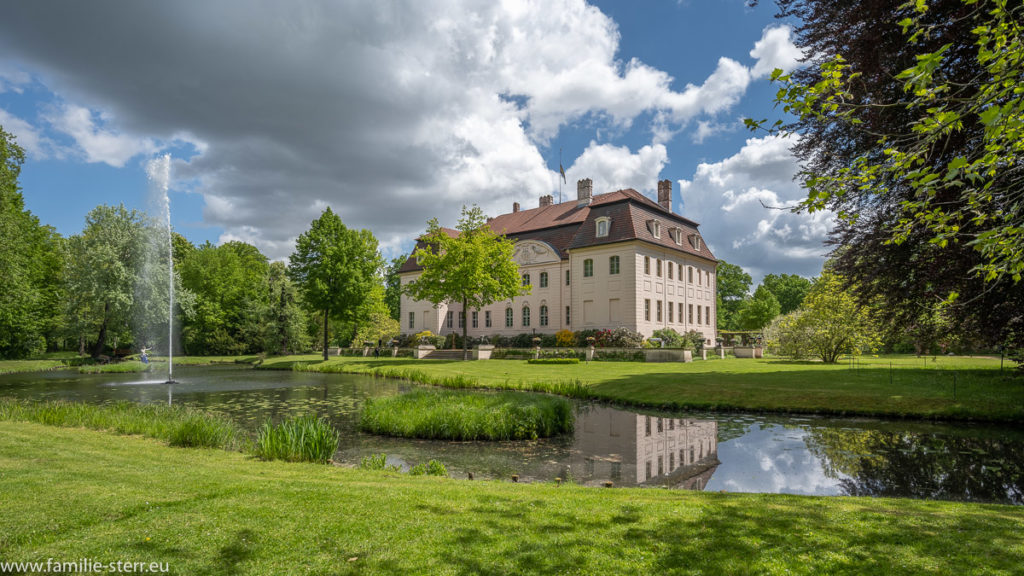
[{"left": 767, "top": 264, "right": 877, "bottom": 363}]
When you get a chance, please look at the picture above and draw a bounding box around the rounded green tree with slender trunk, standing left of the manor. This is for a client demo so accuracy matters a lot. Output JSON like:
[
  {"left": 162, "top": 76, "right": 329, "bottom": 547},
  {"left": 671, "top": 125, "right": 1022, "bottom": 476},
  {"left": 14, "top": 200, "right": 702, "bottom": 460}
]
[{"left": 288, "top": 207, "right": 382, "bottom": 361}]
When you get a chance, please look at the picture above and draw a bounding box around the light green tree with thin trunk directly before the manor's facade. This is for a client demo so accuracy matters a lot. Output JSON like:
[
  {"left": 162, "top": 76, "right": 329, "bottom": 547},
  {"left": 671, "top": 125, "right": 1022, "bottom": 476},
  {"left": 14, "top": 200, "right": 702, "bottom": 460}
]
[{"left": 404, "top": 205, "right": 529, "bottom": 359}]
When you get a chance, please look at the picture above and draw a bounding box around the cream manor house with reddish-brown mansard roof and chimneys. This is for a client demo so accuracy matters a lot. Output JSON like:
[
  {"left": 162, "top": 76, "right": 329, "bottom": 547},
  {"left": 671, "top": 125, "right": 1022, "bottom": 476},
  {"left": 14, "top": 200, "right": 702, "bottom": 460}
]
[{"left": 399, "top": 178, "right": 717, "bottom": 344}]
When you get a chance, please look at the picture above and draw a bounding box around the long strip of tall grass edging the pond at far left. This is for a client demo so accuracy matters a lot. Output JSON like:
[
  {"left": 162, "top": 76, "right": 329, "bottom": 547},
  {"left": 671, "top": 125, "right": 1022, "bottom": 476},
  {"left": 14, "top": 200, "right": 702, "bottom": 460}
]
[{"left": 0, "top": 398, "right": 242, "bottom": 448}]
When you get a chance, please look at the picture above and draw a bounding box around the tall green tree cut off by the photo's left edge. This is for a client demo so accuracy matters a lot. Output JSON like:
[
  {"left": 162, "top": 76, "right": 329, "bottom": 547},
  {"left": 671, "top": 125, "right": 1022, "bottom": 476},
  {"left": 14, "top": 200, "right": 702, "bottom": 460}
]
[{"left": 0, "top": 127, "right": 62, "bottom": 358}]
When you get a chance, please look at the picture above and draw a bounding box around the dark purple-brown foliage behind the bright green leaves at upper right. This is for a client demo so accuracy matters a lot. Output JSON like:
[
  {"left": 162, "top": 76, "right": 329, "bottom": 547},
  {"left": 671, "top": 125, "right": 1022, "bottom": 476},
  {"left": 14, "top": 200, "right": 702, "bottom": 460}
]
[{"left": 777, "top": 0, "right": 1024, "bottom": 354}]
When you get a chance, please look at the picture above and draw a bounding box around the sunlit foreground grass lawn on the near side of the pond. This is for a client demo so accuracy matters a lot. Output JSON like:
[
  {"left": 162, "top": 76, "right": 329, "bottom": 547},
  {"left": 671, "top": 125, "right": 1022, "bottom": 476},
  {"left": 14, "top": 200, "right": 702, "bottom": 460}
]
[{"left": 0, "top": 416, "right": 1024, "bottom": 576}]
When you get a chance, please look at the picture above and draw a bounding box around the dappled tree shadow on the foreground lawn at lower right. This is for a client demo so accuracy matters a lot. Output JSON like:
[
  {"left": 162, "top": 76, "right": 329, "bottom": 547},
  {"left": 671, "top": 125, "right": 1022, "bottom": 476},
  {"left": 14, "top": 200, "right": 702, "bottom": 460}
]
[{"left": 439, "top": 495, "right": 1024, "bottom": 575}]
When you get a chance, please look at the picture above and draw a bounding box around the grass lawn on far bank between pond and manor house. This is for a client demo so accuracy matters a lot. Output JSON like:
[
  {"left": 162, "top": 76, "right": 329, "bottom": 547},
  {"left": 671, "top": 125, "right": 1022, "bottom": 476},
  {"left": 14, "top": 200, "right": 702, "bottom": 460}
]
[{"left": 262, "top": 356, "right": 1024, "bottom": 421}]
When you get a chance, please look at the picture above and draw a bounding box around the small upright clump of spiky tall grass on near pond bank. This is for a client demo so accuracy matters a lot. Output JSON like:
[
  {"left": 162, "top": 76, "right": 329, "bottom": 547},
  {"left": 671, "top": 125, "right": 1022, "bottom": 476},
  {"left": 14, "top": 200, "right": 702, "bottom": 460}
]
[{"left": 255, "top": 414, "right": 341, "bottom": 464}]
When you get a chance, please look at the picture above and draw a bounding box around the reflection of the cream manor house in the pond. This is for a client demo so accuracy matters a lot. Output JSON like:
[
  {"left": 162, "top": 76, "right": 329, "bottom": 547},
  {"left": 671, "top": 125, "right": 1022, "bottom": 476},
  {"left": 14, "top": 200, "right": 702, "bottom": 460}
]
[{"left": 573, "top": 406, "right": 719, "bottom": 490}]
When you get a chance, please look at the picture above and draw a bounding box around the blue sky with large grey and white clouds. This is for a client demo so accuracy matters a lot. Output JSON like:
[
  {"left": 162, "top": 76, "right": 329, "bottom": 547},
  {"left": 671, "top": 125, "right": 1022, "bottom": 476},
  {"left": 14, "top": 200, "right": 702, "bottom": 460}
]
[{"left": 0, "top": 0, "right": 829, "bottom": 279}]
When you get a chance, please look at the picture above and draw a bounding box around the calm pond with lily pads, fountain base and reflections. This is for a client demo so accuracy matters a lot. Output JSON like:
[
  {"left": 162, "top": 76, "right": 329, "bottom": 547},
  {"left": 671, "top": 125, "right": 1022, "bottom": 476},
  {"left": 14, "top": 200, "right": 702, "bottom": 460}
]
[{"left": 0, "top": 366, "right": 1024, "bottom": 504}]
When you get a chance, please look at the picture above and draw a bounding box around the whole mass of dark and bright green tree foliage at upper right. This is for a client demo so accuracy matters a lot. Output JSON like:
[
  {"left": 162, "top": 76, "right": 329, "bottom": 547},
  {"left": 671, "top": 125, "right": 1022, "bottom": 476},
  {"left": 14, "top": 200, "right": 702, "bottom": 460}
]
[{"left": 750, "top": 0, "right": 1024, "bottom": 356}]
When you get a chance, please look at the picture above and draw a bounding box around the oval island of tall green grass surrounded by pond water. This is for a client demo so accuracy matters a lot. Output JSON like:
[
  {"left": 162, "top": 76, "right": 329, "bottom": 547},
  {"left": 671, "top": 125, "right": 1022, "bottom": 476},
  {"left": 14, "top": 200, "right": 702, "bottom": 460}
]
[{"left": 359, "top": 390, "right": 572, "bottom": 440}]
